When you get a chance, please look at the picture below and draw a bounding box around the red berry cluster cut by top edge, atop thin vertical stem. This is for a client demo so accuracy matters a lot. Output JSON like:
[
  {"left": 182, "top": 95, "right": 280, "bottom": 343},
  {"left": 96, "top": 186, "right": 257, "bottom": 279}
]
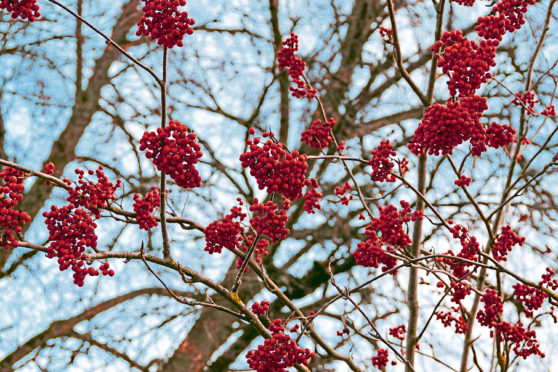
[{"left": 136, "top": 0, "right": 195, "bottom": 48}]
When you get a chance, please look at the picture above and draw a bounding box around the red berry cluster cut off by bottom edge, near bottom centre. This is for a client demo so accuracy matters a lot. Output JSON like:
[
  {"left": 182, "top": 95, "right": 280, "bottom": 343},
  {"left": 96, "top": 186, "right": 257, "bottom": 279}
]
[{"left": 246, "top": 319, "right": 316, "bottom": 372}]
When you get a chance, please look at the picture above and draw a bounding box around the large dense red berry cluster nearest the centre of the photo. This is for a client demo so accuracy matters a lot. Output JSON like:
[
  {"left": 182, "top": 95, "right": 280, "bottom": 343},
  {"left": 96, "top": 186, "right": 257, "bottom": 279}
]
[{"left": 240, "top": 132, "right": 308, "bottom": 200}]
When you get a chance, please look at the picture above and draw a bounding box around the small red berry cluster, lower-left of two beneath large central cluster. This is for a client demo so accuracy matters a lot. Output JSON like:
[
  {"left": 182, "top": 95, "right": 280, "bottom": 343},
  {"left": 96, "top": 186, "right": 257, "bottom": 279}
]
[{"left": 204, "top": 198, "right": 246, "bottom": 254}]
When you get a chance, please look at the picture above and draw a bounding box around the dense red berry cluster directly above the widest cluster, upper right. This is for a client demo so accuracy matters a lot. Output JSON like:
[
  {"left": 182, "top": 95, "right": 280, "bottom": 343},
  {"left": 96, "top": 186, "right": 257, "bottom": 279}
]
[{"left": 432, "top": 30, "right": 498, "bottom": 97}]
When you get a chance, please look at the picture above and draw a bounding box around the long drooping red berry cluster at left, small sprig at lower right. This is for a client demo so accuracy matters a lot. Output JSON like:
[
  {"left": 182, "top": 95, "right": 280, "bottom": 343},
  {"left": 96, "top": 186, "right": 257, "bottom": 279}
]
[{"left": 43, "top": 204, "right": 114, "bottom": 287}]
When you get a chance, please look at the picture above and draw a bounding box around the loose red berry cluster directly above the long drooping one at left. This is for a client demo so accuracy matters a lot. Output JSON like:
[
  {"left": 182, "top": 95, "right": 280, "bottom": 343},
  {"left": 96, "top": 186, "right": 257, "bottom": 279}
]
[{"left": 65, "top": 165, "right": 121, "bottom": 218}]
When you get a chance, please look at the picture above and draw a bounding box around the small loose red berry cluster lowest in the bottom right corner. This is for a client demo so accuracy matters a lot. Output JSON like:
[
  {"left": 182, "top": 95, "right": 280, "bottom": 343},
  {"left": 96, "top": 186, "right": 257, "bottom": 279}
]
[{"left": 491, "top": 322, "right": 545, "bottom": 359}]
